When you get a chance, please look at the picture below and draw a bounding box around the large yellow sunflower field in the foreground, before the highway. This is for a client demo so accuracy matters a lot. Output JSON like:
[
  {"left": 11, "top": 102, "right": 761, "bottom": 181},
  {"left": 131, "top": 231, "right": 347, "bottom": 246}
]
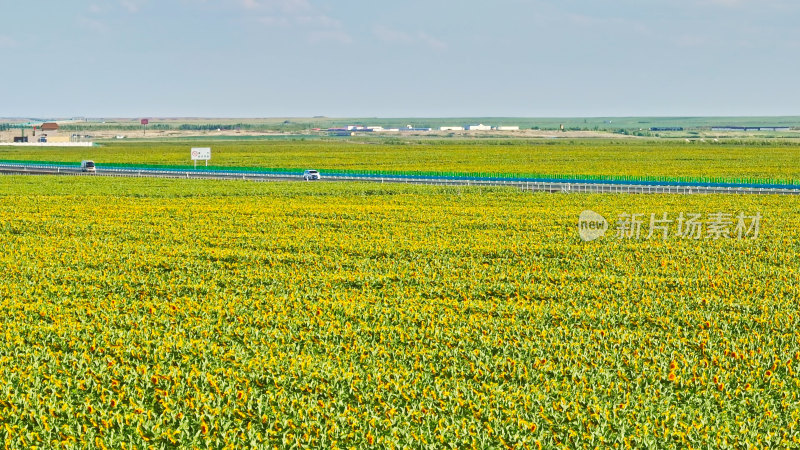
[{"left": 0, "top": 176, "right": 800, "bottom": 449}]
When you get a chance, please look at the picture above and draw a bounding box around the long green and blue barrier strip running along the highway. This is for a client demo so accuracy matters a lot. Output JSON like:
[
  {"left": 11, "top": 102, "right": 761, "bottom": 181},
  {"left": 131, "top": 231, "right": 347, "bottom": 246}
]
[{"left": 0, "top": 161, "right": 800, "bottom": 189}]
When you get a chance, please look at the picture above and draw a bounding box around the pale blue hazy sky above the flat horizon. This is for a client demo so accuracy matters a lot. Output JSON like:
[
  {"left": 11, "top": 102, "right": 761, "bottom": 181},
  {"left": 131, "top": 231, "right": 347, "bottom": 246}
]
[{"left": 0, "top": 0, "right": 800, "bottom": 117}]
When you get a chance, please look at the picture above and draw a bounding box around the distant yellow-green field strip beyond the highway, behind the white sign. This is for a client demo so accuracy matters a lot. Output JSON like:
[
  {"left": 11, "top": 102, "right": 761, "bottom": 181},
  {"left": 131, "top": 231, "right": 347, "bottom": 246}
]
[{"left": 0, "top": 138, "right": 800, "bottom": 180}]
